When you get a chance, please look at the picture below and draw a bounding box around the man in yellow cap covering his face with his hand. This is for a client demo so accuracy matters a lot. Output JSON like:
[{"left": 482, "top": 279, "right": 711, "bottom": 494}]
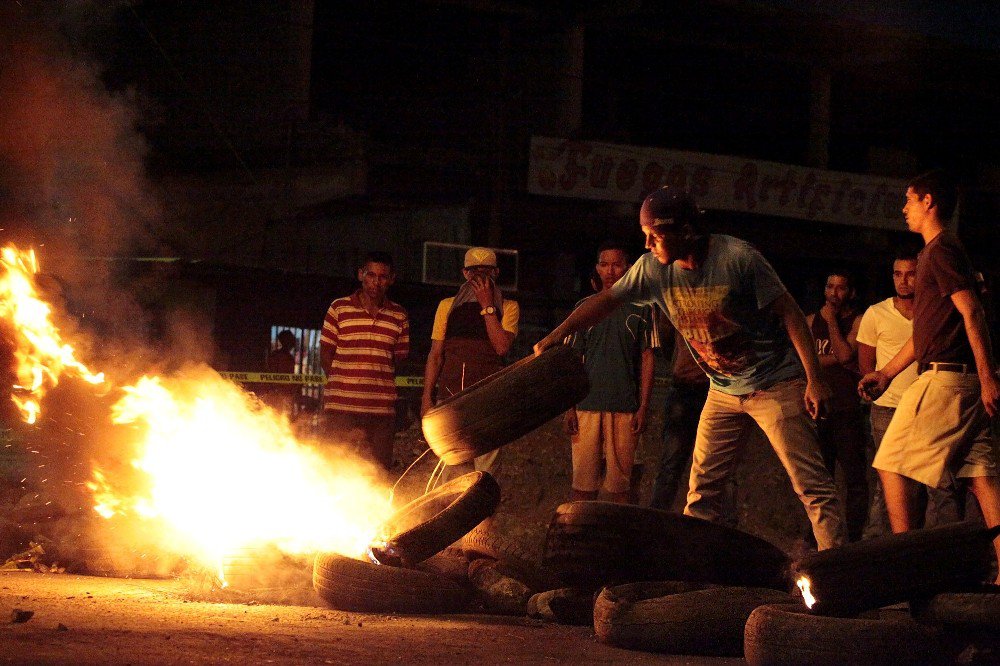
[{"left": 420, "top": 247, "right": 521, "bottom": 478}]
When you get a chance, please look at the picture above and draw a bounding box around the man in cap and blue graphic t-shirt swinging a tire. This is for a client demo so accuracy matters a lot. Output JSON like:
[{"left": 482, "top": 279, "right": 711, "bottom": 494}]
[{"left": 535, "top": 187, "right": 846, "bottom": 550}]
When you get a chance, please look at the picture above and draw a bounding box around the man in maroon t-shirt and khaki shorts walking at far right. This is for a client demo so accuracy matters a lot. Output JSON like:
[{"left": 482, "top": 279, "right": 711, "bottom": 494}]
[{"left": 858, "top": 171, "right": 1000, "bottom": 583}]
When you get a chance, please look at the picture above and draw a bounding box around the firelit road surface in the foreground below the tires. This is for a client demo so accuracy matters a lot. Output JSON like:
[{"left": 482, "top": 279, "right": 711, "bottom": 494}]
[{"left": 0, "top": 571, "right": 743, "bottom": 665}]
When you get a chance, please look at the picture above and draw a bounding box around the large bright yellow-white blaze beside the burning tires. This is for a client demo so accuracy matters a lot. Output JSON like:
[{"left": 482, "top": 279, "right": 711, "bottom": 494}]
[{"left": 92, "top": 368, "right": 390, "bottom": 566}]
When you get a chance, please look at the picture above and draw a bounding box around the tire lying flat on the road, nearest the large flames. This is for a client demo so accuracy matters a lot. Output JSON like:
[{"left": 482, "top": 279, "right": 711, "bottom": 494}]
[{"left": 313, "top": 553, "right": 469, "bottom": 614}]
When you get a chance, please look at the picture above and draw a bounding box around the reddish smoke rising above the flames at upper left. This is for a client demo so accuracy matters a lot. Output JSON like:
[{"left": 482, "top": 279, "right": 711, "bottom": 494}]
[{"left": 0, "top": 0, "right": 166, "bottom": 348}]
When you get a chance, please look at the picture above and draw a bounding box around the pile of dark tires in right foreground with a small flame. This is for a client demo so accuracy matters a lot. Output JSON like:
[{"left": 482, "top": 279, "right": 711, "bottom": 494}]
[{"left": 529, "top": 502, "right": 1000, "bottom": 664}]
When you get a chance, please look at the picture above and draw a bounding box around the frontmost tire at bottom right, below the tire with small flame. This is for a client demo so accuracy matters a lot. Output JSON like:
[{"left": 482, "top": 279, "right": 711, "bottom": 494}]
[{"left": 743, "top": 604, "right": 945, "bottom": 666}]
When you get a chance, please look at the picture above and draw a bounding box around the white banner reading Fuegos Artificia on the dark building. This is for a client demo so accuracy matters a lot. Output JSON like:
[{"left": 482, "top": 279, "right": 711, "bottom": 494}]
[{"left": 528, "top": 136, "right": 906, "bottom": 231}]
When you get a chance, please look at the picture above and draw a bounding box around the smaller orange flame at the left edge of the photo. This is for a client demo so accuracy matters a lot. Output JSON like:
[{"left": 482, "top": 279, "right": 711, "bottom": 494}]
[{"left": 0, "top": 245, "right": 104, "bottom": 423}]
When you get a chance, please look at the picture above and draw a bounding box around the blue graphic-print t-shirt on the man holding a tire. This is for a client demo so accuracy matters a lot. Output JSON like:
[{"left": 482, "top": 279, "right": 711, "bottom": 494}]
[{"left": 611, "top": 234, "right": 804, "bottom": 395}]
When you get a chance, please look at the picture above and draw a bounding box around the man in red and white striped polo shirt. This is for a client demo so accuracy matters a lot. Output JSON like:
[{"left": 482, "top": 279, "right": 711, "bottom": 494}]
[{"left": 320, "top": 252, "right": 410, "bottom": 470}]
